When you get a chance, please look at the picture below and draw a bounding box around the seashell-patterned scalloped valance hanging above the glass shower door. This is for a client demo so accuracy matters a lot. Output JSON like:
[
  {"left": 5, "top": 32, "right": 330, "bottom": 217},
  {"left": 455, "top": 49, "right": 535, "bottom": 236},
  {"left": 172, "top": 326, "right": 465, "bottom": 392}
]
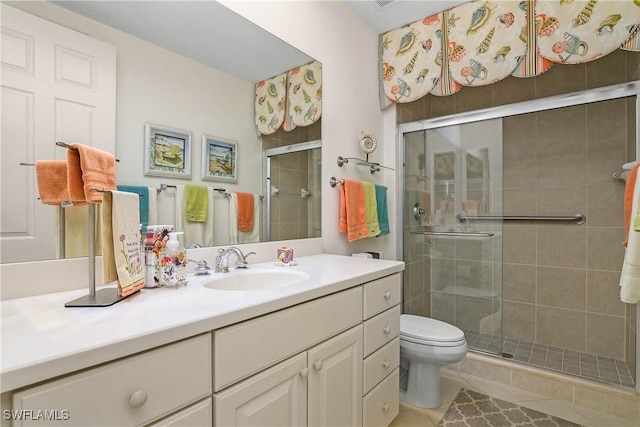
[{"left": 380, "top": 0, "right": 640, "bottom": 109}]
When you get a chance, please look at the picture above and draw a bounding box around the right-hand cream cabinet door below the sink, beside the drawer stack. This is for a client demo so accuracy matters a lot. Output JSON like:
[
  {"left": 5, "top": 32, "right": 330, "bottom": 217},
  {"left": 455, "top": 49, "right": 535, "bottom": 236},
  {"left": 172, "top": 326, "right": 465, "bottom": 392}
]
[{"left": 308, "top": 325, "right": 363, "bottom": 426}]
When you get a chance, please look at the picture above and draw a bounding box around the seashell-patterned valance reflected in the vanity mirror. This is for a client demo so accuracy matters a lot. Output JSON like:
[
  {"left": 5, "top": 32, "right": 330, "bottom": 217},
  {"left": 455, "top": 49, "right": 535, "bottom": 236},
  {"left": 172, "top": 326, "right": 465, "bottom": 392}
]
[{"left": 255, "top": 61, "right": 322, "bottom": 135}]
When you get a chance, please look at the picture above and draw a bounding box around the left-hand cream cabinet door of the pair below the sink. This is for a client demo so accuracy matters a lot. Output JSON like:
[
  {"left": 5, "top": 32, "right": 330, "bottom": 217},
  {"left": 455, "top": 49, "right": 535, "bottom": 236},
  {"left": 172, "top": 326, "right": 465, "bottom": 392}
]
[{"left": 213, "top": 353, "right": 309, "bottom": 427}]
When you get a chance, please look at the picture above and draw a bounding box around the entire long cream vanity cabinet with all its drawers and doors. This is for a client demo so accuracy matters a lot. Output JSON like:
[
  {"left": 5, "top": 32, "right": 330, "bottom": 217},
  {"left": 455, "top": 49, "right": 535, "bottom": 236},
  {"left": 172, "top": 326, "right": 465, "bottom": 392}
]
[{"left": 1, "top": 257, "right": 400, "bottom": 427}]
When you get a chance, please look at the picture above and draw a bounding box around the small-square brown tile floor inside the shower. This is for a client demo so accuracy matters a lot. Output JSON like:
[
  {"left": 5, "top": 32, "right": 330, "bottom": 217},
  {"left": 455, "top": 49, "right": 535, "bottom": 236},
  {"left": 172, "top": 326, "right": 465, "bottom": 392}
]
[{"left": 465, "top": 331, "right": 635, "bottom": 387}]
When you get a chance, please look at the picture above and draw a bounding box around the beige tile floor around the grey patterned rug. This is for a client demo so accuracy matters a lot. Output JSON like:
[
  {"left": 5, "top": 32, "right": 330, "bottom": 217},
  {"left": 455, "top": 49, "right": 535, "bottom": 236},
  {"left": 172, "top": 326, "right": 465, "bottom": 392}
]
[{"left": 390, "top": 369, "right": 640, "bottom": 427}]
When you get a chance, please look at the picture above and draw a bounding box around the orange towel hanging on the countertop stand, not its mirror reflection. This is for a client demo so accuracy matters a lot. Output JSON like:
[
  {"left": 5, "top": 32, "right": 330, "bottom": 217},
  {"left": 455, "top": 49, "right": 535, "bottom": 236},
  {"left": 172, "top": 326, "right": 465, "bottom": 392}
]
[{"left": 67, "top": 144, "right": 116, "bottom": 204}]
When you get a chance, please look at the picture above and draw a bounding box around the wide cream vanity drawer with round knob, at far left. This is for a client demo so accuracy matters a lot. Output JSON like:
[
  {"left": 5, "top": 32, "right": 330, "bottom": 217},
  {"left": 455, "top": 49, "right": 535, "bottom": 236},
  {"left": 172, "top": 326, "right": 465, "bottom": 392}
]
[{"left": 13, "top": 334, "right": 212, "bottom": 426}]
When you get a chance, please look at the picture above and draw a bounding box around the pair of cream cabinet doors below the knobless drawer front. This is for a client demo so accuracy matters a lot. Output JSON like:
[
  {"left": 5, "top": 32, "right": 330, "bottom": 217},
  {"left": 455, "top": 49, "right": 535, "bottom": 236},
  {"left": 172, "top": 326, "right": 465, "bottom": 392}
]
[{"left": 214, "top": 325, "right": 362, "bottom": 426}]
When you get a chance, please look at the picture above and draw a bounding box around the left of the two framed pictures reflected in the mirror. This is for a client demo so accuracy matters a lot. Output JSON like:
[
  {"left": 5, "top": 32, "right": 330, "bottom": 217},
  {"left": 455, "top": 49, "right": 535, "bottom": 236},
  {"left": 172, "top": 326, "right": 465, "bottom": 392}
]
[{"left": 144, "top": 123, "right": 191, "bottom": 179}]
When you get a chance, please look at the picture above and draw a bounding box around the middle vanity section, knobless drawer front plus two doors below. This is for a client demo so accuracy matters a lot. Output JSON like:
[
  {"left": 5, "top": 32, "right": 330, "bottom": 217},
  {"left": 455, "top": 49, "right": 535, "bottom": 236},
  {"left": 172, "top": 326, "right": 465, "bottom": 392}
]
[{"left": 214, "top": 286, "right": 363, "bottom": 426}]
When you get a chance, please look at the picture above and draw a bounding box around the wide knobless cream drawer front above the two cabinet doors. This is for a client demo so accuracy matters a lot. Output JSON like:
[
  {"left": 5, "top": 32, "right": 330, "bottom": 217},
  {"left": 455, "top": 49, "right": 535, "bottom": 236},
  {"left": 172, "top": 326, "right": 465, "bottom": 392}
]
[{"left": 214, "top": 286, "right": 362, "bottom": 392}]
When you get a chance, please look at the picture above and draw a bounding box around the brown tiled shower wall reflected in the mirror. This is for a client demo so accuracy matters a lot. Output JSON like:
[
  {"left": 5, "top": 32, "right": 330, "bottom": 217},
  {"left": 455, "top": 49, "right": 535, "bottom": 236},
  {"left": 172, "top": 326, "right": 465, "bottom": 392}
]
[{"left": 262, "top": 120, "right": 321, "bottom": 241}]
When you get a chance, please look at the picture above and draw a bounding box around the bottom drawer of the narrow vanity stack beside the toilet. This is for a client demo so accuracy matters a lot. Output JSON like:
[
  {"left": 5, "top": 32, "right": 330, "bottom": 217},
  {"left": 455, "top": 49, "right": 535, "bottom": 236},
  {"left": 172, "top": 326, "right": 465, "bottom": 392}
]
[{"left": 362, "top": 368, "right": 400, "bottom": 427}]
